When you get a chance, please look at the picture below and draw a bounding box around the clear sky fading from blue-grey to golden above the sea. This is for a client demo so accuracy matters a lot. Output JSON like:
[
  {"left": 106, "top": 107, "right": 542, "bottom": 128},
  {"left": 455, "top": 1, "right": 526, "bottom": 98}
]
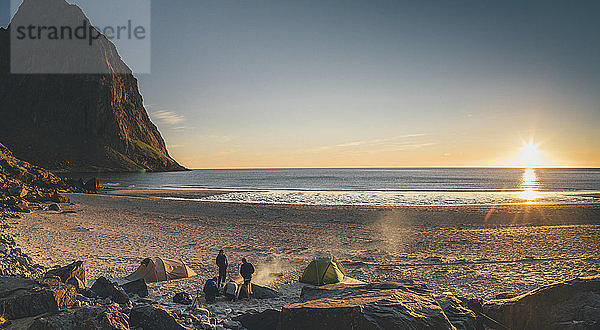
[{"left": 0, "top": 0, "right": 600, "bottom": 168}]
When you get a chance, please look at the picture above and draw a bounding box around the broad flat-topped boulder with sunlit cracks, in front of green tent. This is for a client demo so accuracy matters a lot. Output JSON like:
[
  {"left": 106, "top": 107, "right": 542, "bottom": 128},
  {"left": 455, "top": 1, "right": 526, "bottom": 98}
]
[{"left": 279, "top": 282, "right": 454, "bottom": 329}]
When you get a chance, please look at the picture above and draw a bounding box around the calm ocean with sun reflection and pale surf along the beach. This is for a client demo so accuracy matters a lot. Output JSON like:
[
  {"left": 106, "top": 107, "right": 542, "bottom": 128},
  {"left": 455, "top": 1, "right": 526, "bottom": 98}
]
[{"left": 81, "top": 168, "right": 600, "bottom": 206}]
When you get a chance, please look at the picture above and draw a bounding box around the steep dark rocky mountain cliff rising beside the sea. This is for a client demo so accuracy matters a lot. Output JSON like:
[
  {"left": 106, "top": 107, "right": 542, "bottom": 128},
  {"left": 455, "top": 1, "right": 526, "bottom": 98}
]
[{"left": 0, "top": 0, "right": 184, "bottom": 171}]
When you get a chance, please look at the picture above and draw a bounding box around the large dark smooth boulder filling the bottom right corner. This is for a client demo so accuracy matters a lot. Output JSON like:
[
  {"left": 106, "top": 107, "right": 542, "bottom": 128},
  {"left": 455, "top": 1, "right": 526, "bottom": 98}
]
[{"left": 483, "top": 275, "right": 600, "bottom": 329}]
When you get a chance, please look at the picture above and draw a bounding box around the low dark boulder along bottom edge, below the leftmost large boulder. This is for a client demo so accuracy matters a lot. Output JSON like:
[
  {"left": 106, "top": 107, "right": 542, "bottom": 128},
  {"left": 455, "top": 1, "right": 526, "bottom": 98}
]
[{"left": 29, "top": 306, "right": 129, "bottom": 330}]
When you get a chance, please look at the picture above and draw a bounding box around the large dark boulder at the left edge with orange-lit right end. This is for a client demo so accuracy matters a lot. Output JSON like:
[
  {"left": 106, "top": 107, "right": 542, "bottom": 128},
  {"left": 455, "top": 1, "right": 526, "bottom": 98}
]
[{"left": 0, "top": 277, "right": 77, "bottom": 319}]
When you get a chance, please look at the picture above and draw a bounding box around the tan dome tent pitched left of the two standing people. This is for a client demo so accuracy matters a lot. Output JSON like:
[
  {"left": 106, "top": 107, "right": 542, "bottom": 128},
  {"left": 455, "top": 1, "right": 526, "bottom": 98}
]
[{"left": 125, "top": 258, "right": 196, "bottom": 282}]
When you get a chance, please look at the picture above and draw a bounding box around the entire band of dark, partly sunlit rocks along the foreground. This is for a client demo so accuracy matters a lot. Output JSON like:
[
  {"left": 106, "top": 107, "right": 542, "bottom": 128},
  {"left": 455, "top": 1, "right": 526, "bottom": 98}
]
[{"left": 0, "top": 229, "right": 600, "bottom": 329}]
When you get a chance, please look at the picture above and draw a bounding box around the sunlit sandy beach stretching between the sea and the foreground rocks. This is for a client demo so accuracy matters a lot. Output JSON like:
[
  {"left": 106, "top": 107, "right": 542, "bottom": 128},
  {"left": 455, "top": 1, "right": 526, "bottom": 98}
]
[{"left": 12, "top": 190, "right": 600, "bottom": 309}]
